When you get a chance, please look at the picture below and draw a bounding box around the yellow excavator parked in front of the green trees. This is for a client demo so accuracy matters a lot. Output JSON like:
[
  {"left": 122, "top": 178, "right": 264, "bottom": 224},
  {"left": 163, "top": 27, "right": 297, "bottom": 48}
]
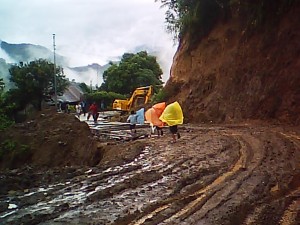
[{"left": 113, "top": 86, "right": 153, "bottom": 112}]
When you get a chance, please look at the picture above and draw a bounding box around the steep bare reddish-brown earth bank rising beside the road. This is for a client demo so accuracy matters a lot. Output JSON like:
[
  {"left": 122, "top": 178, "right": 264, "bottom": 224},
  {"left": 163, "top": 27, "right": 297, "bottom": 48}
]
[{"left": 166, "top": 1, "right": 300, "bottom": 124}]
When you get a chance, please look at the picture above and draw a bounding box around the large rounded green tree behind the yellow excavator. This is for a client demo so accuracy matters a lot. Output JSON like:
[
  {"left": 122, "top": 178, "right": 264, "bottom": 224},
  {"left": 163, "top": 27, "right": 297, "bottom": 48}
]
[{"left": 100, "top": 51, "right": 163, "bottom": 95}]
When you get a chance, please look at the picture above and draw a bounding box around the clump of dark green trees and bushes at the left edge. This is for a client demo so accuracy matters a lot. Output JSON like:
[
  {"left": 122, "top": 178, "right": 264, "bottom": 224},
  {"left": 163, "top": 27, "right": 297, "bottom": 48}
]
[{"left": 0, "top": 59, "right": 68, "bottom": 126}]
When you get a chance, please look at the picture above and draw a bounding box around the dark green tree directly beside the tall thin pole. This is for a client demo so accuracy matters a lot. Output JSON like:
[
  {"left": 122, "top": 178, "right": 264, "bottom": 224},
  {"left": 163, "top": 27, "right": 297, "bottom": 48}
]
[{"left": 9, "top": 59, "right": 68, "bottom": 110}]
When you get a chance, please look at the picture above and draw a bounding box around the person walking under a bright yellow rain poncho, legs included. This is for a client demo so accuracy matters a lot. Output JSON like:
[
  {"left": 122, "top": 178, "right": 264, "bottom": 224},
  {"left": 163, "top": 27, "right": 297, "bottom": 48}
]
[{"left": 159, "top": 101, "right": 183, "bottom": 142}]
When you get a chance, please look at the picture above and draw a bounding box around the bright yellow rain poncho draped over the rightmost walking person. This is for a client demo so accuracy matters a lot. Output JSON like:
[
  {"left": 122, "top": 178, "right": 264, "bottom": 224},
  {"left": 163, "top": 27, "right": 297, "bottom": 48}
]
[{"left": 159, "top": 101, "right": 183, "bottom": 126}]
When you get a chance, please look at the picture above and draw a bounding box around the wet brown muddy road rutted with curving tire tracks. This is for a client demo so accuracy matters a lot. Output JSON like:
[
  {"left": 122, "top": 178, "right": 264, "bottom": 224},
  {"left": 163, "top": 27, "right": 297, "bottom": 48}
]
[{"left": 0, "top": 124, "right": 300, "bottom": 225}]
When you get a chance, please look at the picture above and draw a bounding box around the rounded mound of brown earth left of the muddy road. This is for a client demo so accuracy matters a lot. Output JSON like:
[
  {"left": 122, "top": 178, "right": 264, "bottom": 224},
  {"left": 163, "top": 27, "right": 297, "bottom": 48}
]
[{"left": 0, "top": 109, "right": 102, "bottom": 168}]
